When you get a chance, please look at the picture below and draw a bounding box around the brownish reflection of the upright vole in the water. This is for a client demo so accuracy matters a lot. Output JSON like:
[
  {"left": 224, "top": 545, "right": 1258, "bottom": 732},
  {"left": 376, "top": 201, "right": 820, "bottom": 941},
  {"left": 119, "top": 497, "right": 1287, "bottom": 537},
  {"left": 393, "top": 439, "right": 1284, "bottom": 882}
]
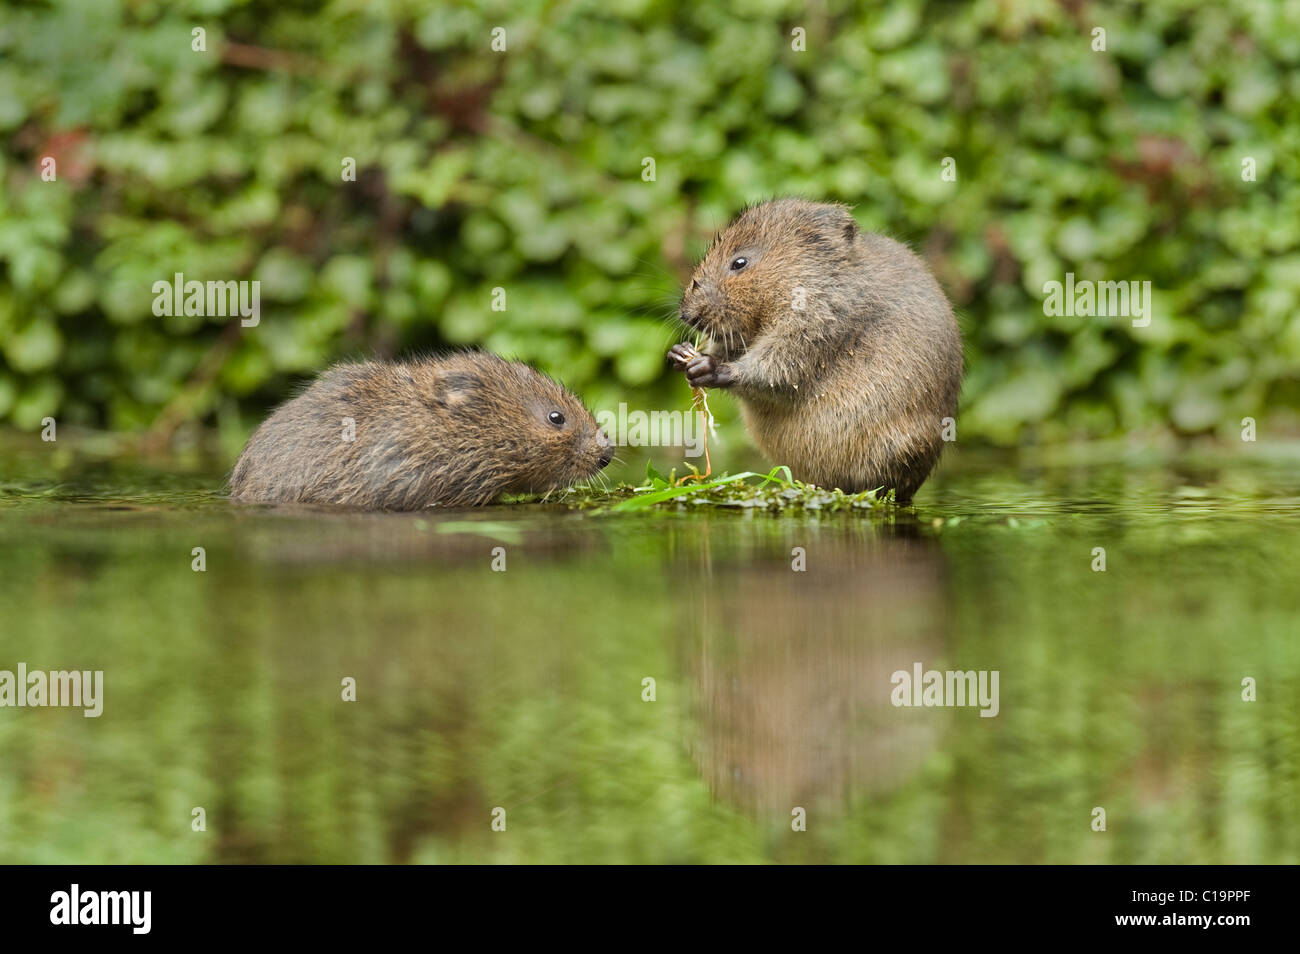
[{"left": 681, "top": 534, "right": 949, "bottom": 818}]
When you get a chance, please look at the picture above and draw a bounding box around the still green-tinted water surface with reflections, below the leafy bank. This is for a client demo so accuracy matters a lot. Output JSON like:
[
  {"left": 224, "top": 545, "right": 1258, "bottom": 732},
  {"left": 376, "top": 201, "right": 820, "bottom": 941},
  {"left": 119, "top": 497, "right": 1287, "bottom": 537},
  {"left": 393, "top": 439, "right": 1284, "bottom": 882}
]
[{"left": 0, "top": 446, "right": 1300, "bottom": 863}]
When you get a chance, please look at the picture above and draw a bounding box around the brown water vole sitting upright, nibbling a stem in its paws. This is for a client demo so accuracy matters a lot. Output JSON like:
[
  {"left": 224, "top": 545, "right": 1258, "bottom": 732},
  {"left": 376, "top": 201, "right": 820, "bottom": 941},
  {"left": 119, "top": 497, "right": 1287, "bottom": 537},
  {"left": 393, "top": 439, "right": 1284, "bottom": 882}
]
[{"left": 668, "top": 199, "right": 962, "bottom": 503}]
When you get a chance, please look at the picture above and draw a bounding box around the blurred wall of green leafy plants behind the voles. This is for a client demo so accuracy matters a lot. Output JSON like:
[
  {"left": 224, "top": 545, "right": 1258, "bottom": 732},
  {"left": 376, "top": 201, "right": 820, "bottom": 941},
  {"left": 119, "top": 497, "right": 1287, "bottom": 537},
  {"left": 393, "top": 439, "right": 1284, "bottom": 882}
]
[{"left": 0, "top": 0, "right": 1300, "bottom": 454}]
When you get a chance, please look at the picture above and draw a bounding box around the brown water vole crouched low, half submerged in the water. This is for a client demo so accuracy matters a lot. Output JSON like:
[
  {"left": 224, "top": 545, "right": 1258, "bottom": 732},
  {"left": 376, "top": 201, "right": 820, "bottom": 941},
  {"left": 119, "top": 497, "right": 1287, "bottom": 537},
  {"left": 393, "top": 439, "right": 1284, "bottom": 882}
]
[{"left": 230, "top": 352, "right": 614, "bottom": 509}]
